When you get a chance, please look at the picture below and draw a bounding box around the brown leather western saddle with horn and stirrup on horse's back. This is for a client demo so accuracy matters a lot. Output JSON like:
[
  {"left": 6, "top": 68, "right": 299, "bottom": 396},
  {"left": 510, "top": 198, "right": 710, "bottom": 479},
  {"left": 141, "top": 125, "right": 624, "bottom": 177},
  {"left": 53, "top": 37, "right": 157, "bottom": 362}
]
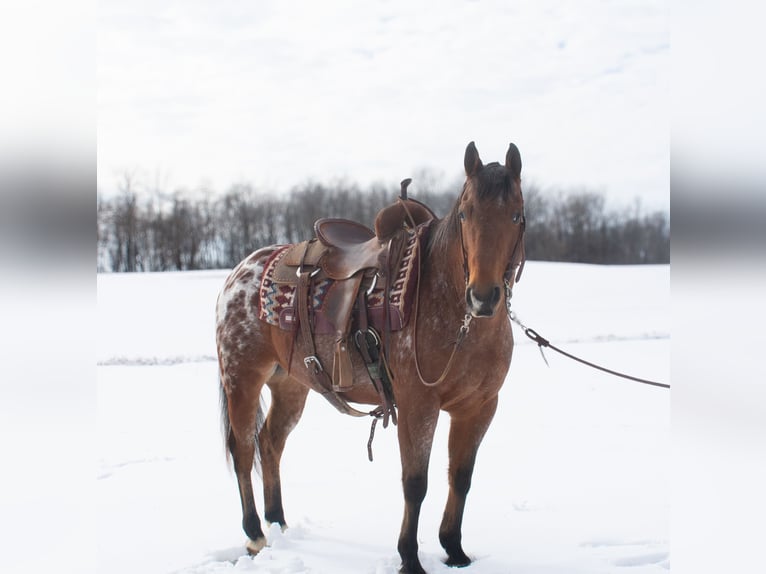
[{"left": 275, "top": 179, "right": 436, "bottom": 427}]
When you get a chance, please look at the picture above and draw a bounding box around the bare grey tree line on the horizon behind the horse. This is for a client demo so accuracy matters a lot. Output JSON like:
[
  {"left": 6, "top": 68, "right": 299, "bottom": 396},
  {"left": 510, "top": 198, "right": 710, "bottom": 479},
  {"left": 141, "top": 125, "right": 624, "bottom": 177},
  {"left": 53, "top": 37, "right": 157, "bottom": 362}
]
[{"left": 97, "top": 175, "right": 670, "bottom": 272}]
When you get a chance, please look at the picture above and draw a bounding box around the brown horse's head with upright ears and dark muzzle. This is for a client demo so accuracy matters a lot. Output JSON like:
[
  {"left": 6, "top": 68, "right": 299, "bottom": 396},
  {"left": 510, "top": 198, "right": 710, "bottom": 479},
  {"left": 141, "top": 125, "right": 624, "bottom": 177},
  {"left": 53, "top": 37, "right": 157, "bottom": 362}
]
[{"left": 456, "top": 142, "right": 525, "bottom": 317}]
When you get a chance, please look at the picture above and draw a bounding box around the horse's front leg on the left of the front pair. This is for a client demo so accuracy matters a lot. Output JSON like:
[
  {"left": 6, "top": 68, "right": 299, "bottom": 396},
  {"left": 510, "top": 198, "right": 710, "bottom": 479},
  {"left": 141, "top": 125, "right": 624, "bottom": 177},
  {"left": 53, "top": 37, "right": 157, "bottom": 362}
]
[{"left": 398, "top": 401, "right": 439, "bottom": 574}]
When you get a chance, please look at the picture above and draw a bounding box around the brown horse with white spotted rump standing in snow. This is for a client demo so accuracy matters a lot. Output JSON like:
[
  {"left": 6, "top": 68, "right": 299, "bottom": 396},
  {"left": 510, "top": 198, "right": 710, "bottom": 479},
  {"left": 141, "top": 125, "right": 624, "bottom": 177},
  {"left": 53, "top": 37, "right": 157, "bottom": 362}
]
[{"left": 216, "top": 142, "right": 525, "bottom": 574}]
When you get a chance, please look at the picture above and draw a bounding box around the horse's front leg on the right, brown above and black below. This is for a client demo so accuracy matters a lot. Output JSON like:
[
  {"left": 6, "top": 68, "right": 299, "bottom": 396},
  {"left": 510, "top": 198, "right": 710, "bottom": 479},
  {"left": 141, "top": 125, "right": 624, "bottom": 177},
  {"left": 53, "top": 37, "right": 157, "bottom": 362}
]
[{"left": 439, "top": 396, "right": 497, "bottom": 567}]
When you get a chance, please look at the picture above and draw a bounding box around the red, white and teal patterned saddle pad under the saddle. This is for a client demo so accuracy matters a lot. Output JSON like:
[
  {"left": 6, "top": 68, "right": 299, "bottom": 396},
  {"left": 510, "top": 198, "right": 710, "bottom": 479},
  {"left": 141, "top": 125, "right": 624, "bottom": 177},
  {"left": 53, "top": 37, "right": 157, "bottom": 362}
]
[{"left": 258, "top": 225, "right": 428, "bottom": 334}]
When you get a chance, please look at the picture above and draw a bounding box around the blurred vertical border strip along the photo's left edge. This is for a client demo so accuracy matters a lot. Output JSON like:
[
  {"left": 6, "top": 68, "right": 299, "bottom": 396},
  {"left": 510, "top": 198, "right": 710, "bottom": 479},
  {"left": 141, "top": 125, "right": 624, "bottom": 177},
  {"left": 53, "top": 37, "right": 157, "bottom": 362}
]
[{"left": 0, "top": 0, "right": 98, "bottom": 573}]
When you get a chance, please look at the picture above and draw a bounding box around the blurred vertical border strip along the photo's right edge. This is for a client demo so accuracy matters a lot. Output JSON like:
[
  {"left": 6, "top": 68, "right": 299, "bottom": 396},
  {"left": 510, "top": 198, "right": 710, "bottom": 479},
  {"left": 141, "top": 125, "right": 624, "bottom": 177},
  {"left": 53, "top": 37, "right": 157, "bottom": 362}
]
[{"left": 669, "top": 0, "right": 766, "bottom": 574}]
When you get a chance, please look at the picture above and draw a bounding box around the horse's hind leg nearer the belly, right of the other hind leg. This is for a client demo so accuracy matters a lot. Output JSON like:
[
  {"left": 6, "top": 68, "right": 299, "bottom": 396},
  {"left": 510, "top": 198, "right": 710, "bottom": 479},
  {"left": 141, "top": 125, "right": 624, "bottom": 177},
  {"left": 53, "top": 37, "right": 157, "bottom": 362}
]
[{"left": 260, "top": 369, "right": 309, "bottom": 530}]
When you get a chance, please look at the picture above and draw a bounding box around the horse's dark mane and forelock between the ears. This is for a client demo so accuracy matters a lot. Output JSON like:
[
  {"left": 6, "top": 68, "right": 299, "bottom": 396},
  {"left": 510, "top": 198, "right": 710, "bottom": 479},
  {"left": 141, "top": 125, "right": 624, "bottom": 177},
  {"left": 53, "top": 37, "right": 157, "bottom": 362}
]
[{"left": 427, "top": 162, "right": 515, "bottom": 257}]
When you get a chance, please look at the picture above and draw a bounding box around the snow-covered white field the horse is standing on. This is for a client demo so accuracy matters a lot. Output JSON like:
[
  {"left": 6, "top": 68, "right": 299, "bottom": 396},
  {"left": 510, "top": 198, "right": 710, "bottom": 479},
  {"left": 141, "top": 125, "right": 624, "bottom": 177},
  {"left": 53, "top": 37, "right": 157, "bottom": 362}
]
[{"left": 96, "top": 262, "right": 671, "bottom": 574}]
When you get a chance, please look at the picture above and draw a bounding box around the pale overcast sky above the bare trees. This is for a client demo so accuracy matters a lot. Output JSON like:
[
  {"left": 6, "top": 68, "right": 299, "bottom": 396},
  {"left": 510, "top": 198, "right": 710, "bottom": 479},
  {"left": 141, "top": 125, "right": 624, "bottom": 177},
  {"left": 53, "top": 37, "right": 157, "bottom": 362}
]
[{"left": 98, "top": 0, "right": 670, "bottom": 209}]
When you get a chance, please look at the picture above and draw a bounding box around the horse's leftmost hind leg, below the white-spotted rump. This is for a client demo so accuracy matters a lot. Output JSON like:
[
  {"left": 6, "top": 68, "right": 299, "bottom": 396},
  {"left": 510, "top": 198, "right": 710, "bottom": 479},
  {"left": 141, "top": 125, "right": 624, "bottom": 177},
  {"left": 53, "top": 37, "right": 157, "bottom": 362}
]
[{"left": 222, "top": 365, "right": 274, "bottom": 554}]
